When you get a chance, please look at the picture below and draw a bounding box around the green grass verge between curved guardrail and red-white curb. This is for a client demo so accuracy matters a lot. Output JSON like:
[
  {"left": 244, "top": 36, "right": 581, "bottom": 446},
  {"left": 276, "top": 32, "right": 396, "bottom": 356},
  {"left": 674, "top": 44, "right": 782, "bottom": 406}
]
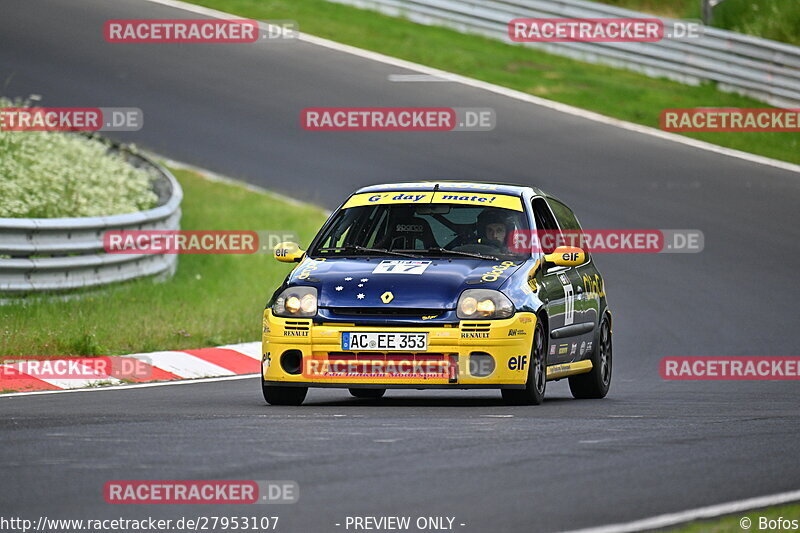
[{"left": 0, "top": 171, "right": 325, "bottom": 358}]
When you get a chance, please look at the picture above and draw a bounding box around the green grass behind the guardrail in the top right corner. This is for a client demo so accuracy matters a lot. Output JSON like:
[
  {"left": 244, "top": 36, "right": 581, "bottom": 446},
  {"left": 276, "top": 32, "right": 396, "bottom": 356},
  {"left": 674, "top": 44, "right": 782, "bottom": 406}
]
[{"left": 597, "top": 0, "right": 800, "bottom": 45}]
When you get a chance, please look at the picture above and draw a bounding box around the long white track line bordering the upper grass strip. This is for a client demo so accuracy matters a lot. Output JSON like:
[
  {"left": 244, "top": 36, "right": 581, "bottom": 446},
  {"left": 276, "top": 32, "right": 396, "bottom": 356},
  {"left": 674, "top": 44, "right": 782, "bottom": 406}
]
[{"left": 143, "top": 0, "right": 800, "bottom": 173}]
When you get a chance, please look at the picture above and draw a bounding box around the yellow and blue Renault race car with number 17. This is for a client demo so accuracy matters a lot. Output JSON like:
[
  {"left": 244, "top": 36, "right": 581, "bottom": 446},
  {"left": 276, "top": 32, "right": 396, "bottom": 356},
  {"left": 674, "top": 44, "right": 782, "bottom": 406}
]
[{"left": 262, "top": 181, "right": 612, "bottom": 405}]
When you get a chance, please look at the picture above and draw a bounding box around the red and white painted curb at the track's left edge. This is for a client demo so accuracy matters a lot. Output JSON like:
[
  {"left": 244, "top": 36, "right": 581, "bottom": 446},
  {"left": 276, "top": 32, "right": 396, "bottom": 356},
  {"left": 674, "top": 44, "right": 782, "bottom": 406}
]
[{"left": 0, "top": 342, "right": 261, "bottom": 392}]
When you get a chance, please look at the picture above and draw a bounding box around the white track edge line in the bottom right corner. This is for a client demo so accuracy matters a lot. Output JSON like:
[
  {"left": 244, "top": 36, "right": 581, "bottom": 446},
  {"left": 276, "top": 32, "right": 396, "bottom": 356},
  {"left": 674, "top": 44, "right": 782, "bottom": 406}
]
[{"left": 567, "top": 490, "right": 800, "bottom": 533}]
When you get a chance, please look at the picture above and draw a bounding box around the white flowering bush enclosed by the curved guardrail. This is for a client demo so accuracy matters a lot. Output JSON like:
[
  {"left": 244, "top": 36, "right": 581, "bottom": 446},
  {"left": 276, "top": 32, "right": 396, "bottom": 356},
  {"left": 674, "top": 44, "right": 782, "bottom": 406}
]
[{"left": 0, "top": 98, "right": 157, "bottom": 218}]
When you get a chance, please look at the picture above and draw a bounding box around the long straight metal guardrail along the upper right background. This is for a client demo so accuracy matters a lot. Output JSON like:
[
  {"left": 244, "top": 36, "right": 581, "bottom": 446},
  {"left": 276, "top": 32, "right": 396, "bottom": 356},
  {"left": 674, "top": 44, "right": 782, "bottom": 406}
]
[{"left": 329, "top": 0, "right": 800, "bottom": 108}]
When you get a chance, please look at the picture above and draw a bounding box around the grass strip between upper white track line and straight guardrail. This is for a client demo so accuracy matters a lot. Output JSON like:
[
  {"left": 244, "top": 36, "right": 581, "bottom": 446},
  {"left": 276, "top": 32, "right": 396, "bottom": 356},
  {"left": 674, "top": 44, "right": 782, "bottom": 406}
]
[{"left": 186, "top": 0, "right": 800, "bottom": 163}]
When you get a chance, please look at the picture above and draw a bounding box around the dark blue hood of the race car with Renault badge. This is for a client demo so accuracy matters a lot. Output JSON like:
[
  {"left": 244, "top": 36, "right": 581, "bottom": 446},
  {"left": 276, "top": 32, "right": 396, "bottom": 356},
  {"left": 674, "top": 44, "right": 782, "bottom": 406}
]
[{"left": 289, "top": 257, "right": 524, "bottom": 309}]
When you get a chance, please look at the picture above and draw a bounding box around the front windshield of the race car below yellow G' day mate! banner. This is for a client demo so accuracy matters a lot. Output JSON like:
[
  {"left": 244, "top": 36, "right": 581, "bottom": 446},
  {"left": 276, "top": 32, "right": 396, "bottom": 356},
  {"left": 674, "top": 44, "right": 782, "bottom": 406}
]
[{"left": 310, "top": 204, "right": 528, "bottom": 260}]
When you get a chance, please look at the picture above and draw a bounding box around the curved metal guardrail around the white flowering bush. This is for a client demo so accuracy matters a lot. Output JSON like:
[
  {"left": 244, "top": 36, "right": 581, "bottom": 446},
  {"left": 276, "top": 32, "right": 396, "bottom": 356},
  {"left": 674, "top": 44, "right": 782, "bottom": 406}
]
[{"left": 0, "top": 141, "right": 183, "bottom": 296}]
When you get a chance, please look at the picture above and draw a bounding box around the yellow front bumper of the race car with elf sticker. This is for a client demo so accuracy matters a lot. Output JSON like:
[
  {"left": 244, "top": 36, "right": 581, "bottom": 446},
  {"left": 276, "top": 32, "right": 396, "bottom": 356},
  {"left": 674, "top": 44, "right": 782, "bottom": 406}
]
[{"left": 262, "top": 309, "right": 537, "bottom": 389}]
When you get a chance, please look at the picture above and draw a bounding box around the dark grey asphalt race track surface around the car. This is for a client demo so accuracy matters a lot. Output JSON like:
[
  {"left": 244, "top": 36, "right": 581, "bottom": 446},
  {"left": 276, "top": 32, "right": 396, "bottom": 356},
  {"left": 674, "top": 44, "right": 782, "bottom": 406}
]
[{"left": 0, "top": 0, "right": 800, "bottom": 532}]
